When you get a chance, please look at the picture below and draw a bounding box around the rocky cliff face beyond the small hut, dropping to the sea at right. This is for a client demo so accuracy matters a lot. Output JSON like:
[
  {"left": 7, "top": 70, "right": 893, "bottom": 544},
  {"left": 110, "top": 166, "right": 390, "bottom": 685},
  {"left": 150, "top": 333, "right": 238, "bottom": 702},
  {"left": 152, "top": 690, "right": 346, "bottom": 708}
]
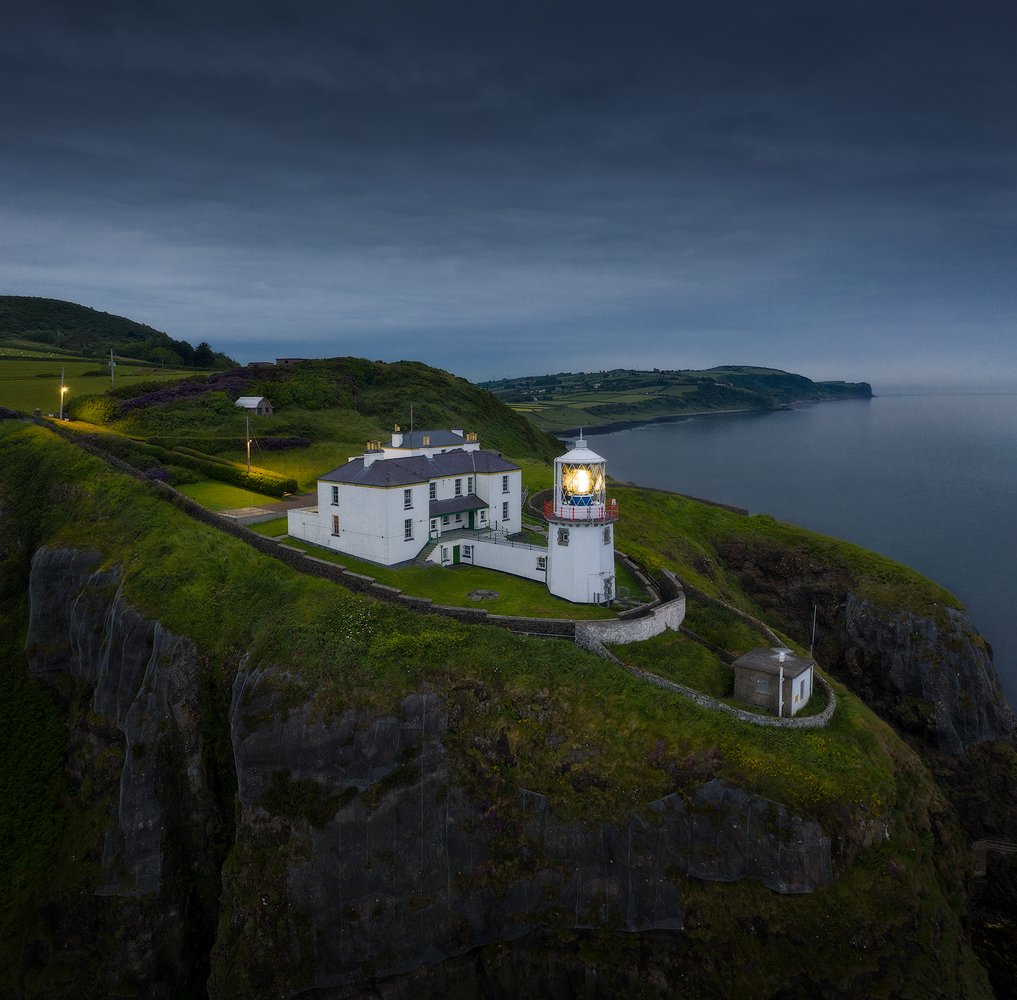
[{"left": 720, "top": 542, "right": 1014, "bottom": 755}]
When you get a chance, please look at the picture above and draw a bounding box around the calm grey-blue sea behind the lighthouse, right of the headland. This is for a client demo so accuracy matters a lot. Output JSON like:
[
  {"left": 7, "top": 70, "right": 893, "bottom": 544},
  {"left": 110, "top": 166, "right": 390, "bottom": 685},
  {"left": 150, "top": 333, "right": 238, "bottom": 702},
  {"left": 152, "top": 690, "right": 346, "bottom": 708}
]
[{"left": 590, "top": 394, "right": 1017, "bottom": 705}]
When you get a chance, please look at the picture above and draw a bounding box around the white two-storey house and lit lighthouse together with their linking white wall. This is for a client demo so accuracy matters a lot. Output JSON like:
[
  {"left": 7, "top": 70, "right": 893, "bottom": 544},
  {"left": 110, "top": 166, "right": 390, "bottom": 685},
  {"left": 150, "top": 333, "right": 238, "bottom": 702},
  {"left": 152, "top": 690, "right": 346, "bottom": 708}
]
[{"left": 288, "top": 426, "right": 617, "bottom": 604}]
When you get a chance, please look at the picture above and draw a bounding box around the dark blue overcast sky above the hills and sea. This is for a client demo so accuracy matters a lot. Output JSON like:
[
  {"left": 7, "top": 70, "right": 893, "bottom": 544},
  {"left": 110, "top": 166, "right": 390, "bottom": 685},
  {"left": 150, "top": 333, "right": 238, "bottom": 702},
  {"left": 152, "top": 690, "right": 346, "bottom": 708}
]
[{"left": 0, "top": 0, "right": 1017, "bottom": 389}]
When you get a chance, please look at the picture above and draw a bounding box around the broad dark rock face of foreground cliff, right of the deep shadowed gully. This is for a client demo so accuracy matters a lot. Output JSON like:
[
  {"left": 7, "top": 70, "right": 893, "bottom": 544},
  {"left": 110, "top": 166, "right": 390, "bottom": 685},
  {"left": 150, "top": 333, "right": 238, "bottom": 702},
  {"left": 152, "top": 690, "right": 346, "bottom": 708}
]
[{"left": 213, "top": 672, "right": 832, "bottom": 995}]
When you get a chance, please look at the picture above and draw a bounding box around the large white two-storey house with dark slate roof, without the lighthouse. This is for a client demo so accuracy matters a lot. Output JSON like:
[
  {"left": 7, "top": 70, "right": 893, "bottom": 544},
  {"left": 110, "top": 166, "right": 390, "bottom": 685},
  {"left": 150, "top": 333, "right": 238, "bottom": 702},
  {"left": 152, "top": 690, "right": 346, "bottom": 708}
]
[{"left": 288, "top": 427, "right": 523, "bottom": 566}]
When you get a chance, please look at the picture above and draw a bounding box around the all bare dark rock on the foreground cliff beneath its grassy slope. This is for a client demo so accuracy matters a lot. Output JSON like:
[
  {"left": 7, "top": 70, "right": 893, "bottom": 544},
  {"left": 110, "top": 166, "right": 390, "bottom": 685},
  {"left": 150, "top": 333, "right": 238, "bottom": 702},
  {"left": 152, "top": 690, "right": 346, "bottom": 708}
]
[{"left": 21, "top": 548, "right": 832, "bottom": 997}]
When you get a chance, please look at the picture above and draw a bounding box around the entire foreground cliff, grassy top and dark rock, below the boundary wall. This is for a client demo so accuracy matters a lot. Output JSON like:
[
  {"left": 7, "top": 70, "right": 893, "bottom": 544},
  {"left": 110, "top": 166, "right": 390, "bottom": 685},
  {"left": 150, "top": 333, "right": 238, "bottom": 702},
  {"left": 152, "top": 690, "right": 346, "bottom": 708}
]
[{"left": 0, "top": 427, "right": 989, "bottom": 998}]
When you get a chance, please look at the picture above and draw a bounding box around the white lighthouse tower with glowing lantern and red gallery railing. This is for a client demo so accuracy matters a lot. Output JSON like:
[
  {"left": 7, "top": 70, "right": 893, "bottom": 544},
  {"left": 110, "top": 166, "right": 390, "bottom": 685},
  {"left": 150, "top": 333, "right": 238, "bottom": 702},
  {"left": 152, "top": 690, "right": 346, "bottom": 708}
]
[{"left": 544, "top": 437, "right": 618, "bottom": 604}]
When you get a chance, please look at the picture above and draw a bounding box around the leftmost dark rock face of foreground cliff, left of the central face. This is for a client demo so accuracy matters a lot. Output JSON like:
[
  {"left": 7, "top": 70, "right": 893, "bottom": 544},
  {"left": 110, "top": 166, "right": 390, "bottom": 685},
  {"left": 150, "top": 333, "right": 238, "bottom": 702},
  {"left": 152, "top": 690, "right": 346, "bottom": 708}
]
[{"left": 26, "top": 549, "right": 222, "bottom": 997}]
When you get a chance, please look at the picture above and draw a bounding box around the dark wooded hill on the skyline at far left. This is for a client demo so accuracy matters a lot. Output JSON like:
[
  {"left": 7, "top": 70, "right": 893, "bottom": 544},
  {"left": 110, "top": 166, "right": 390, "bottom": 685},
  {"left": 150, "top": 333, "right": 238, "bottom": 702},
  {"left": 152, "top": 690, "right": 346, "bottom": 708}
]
[{"left": 0, "top": 295, "right": 236, "bottom": 368}]
